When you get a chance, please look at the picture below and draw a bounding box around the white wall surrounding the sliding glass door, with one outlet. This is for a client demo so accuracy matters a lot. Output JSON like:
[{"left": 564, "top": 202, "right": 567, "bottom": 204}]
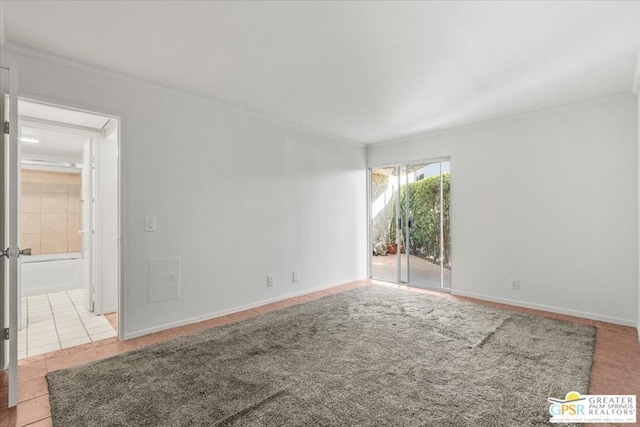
[{"left": 368, "top": 94, "right": 638, "bottom": 325}]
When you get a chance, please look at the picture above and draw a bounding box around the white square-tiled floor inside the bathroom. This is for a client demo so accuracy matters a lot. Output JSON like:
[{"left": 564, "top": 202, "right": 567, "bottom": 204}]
[{"left": 18, "top": 289, "right": 117, "bottom": 359}]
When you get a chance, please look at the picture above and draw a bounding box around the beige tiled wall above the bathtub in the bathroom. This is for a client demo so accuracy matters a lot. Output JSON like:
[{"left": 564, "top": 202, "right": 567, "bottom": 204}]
[{"left": 21, "top": 169, "right": 82, "bottom": 255}]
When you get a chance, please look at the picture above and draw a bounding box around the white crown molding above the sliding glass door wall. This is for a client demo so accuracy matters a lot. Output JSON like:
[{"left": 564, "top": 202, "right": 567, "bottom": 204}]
[{"left": 367, "top": 92, "right": 633, "bottom": 149}]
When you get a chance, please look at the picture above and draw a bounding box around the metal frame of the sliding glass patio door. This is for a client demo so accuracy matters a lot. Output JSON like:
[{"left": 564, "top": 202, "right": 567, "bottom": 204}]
[{"left": 367, "top": 156, "right": 453, "bottom": 293}]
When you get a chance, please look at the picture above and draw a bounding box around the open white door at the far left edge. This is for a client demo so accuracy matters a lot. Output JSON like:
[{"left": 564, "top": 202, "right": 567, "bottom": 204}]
[{"left": 0, "top": 62, "right": 21, "bottom": 407}]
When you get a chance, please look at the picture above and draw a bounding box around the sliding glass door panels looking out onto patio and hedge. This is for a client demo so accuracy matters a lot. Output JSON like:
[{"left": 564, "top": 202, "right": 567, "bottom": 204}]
[{"left": 370, "top": 160, "right": 451, "bottom": 290}]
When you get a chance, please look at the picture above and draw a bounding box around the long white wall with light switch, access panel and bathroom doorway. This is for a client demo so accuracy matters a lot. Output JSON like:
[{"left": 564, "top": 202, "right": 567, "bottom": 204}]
[{"left": 2, "top": 51, "right": 367, "bottom": 337}]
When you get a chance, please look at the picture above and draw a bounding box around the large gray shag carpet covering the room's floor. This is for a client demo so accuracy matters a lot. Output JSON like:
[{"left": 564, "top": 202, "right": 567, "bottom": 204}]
[{"left": 47, "top": 285, "right": 595, "bottom": 427}]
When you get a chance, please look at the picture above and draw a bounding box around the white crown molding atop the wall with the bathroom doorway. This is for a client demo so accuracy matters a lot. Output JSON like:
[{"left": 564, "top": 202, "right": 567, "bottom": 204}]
[{"left": 2, "top": 42, "right": 366, "bottom": 148}]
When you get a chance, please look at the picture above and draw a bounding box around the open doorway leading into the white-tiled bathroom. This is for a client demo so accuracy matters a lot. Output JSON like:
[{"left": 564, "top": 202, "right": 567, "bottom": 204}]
[{"left": 18, "top": 99, "right": 119, "bottom": 359}]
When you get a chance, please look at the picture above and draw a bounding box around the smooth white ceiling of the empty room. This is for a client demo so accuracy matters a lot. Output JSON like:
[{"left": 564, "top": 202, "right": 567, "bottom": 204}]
[{"left": 3, "top": 0, "right": 640, "bottom": 143}]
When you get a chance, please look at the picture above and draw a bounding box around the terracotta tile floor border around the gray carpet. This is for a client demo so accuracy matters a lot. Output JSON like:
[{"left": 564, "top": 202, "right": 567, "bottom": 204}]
[{"left": 0, "top": 280, "right": 640, "bottom": 427}]
